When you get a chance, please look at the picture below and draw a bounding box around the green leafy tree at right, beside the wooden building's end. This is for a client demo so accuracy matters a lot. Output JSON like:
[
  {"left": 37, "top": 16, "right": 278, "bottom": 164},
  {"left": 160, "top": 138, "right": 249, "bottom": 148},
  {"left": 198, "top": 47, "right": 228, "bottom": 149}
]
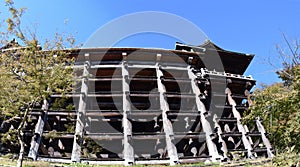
[{"left": 246, "top": 35, "right": 300, "bottom": 153}]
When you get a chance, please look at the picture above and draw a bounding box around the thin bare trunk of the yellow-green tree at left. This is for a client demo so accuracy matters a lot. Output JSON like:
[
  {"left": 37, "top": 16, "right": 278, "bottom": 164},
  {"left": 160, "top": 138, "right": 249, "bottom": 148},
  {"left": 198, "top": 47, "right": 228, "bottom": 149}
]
[{"left": 17, "top": 106, "right": 30, "bottom": 167}]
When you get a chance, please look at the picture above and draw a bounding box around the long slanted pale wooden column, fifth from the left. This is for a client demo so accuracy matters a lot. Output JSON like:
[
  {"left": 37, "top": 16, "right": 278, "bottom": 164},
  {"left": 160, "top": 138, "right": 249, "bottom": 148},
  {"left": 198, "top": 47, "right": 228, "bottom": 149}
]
[{"left": 187, "top": 66, "right": 223, "bottom": 161}]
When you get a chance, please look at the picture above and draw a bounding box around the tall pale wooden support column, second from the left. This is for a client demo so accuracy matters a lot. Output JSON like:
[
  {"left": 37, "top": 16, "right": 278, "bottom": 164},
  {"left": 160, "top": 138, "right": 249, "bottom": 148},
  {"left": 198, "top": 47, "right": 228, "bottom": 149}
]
[{"left": 71, "top": 53, "right": 90, "bottom": 162}]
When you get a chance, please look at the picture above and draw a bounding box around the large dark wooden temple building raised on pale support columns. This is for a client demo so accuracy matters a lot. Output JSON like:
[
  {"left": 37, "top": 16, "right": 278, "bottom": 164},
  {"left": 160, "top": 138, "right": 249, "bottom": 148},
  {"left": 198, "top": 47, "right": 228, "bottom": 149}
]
[{"left": 0, "top": 41, "right": 273, "bottom": 165}]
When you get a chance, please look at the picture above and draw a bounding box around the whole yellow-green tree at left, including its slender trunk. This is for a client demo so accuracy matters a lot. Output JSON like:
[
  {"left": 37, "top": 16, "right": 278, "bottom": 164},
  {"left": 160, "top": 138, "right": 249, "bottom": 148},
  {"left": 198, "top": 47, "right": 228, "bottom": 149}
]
[{"left": 0, "top": 0, "right": 74, "bottom": 166}]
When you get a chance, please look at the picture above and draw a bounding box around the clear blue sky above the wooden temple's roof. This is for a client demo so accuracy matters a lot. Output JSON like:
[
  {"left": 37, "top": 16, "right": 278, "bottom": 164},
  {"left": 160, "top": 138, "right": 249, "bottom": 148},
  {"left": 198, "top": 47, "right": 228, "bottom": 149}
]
[{"left": 0, "top": 0, "right": 300, "bottom": 84}]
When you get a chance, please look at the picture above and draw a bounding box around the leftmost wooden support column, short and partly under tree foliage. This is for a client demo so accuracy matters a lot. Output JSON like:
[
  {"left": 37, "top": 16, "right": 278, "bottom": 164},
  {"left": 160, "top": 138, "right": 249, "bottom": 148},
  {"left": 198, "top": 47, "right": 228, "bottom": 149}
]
[{"left": 28, "top": 100, "right": 49, "bottom": 160}]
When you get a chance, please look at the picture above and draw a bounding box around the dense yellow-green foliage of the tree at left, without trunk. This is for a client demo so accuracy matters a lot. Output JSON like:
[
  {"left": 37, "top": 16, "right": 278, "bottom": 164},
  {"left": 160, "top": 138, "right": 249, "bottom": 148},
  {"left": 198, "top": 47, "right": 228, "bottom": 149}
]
[{"left": 0, "top": 40, "right": 73, "bottom": 116}]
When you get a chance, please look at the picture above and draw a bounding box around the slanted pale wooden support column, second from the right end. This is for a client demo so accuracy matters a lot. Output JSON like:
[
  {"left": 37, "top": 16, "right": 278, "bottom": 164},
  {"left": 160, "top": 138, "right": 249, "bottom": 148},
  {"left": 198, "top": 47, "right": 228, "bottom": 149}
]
[{"left": 225, "top": 87, "right": 254, "bottom": 158}]
